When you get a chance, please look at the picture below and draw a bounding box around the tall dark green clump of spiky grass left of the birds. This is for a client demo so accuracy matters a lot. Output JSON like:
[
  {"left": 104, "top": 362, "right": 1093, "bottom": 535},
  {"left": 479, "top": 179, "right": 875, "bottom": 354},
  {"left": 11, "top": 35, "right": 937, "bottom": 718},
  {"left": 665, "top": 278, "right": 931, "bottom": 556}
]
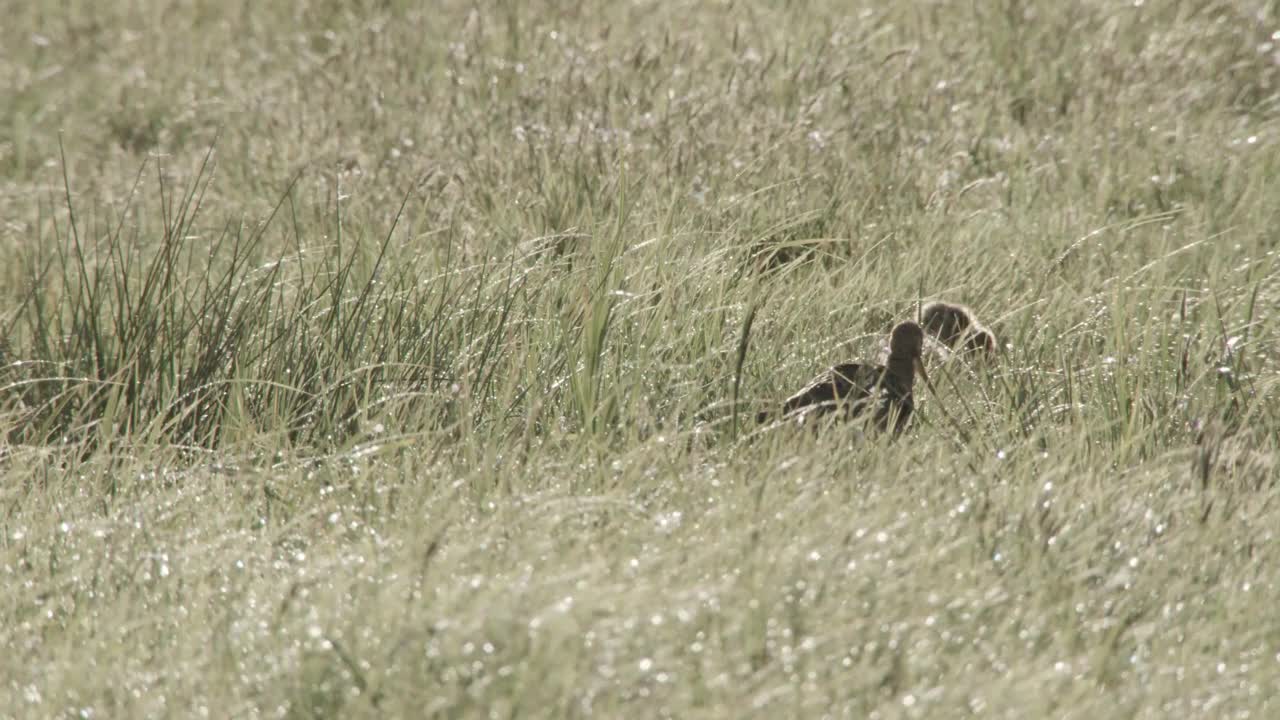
[{"left": 9, "top": 151, "right": 416, "bottom": 448}]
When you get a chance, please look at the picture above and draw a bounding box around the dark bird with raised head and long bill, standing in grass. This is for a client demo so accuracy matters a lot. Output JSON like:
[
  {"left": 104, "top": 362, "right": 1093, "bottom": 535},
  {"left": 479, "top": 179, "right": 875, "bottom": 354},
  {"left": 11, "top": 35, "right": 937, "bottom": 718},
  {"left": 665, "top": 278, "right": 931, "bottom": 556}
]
[{"left": 756, "top": 320, "right": 928, "bottom": 434}]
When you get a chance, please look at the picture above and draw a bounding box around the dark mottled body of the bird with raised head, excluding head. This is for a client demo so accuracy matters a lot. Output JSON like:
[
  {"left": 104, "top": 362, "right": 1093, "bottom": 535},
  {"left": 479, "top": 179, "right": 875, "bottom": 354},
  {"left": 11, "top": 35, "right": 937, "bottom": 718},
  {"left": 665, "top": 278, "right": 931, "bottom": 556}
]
[{"left": 782, "top": 363, "right": 915, "bottom": 433}]
